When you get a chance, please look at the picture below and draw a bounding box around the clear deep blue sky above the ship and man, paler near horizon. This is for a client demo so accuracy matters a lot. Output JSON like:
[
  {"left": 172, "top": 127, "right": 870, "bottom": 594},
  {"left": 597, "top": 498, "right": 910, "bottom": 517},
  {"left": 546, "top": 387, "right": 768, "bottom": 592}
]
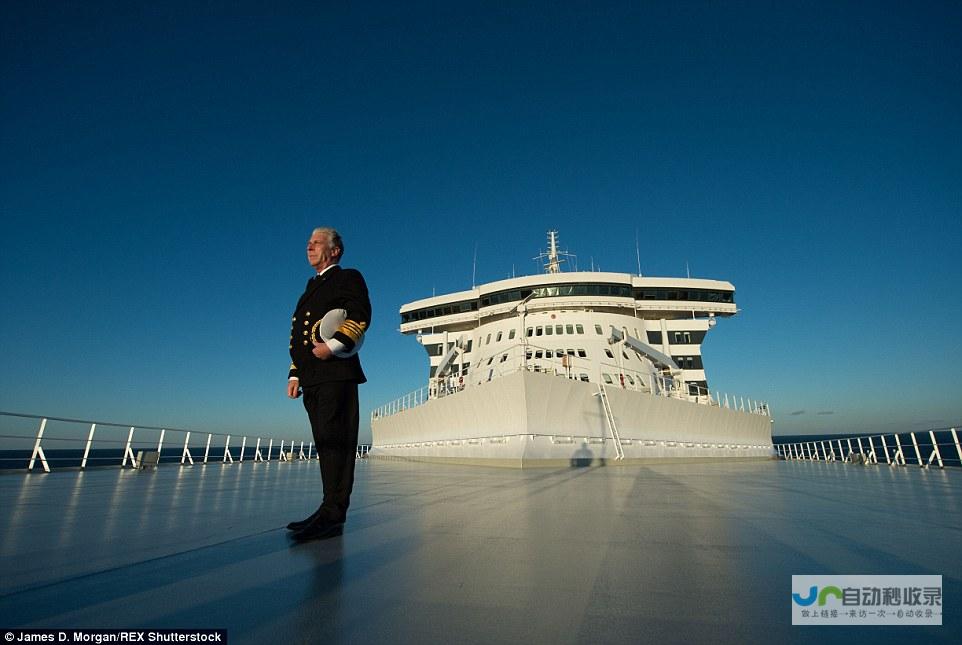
[{"left": 0, "top": 2, "right": 962, "bottom": 437}]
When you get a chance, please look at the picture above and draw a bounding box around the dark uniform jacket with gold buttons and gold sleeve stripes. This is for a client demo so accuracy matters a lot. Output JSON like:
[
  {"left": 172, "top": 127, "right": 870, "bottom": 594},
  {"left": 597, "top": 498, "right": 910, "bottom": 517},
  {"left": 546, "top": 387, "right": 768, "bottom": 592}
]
[{"left": 288, "top": 264, "right": 371, "bottom": 387}]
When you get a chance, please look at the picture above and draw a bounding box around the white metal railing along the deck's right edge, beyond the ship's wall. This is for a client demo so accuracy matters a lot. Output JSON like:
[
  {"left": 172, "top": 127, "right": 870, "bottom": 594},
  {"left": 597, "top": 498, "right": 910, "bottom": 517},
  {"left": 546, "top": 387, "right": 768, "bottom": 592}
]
[{"left": 775, "top": 426, "right": 962, "bottom": 468}]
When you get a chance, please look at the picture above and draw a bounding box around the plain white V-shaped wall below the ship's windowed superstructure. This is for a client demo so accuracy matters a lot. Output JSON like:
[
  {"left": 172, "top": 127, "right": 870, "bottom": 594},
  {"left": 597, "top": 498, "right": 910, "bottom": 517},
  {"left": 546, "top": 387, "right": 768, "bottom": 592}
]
[{"left": 370, "top": 371, "right": 774, "bottom": 467}]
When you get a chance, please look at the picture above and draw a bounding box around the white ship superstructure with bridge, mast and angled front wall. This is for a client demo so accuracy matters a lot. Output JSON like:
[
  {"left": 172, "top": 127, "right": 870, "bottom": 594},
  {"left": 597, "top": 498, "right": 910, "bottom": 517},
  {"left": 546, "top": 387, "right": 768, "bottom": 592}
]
[{"left": 370, "top": 231, "right": 774, "bottom": 467}]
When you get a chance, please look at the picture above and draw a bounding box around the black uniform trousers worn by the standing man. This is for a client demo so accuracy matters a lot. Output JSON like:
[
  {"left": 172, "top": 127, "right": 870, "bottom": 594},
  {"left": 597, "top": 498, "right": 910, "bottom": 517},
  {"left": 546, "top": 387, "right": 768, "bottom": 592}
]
[{"left": 303, "top": 381, "right": 359, "bottom": 522}]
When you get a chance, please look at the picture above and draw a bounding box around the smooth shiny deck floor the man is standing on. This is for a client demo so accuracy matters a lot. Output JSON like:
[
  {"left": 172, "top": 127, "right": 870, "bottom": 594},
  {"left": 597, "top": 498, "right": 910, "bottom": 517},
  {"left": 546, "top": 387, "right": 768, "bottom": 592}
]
[{"left": 0, "top": 460, "right": 962, "bottom": 643}]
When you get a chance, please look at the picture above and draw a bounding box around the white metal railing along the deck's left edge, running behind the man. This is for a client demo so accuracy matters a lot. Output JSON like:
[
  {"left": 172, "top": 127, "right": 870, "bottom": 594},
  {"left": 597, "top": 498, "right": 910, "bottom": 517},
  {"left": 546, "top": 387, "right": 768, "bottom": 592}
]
[{"left": 0, "top": 412, "right": 370, "bottom": 472}]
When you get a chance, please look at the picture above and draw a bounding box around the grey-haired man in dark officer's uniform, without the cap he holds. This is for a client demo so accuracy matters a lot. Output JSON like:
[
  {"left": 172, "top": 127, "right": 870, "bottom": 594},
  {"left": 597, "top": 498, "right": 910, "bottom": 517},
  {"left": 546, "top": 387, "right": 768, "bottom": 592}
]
[{"left": 287, "top": 228, "right": 371, "bottom": 541}]
